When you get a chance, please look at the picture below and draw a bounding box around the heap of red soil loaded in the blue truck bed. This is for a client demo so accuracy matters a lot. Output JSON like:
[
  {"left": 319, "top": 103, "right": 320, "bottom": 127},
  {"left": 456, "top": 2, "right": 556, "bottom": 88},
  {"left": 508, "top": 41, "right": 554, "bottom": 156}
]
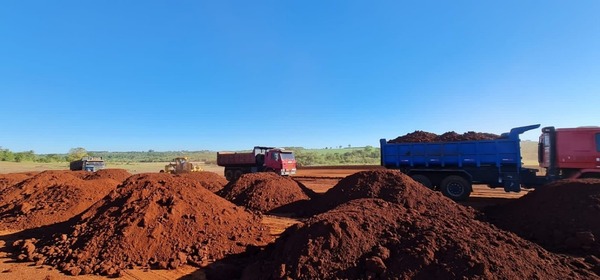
[{"left": 388, "top": 130, "right": 500, "bottom": 143}]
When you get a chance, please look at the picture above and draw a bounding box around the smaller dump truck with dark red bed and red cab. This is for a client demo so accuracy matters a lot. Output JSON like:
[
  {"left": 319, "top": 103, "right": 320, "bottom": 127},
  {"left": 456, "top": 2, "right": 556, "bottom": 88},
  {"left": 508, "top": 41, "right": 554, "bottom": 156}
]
[{"left": 217, "top": 146, "right": 296, "bottom": 181}]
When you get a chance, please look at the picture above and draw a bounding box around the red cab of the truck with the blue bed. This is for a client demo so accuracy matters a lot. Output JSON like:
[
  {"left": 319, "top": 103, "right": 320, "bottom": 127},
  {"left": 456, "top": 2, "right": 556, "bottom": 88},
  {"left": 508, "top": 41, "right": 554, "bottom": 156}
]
[{"left": 538, "top": 127, "right": 600, "bottom": 179}]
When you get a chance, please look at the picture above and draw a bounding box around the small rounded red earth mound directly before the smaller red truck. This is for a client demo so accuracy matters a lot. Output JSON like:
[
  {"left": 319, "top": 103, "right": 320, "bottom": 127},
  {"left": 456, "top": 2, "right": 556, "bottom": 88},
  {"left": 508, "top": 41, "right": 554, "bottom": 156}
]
[{"left": 219, "top": 172, "right": 310, "bottom": 212}]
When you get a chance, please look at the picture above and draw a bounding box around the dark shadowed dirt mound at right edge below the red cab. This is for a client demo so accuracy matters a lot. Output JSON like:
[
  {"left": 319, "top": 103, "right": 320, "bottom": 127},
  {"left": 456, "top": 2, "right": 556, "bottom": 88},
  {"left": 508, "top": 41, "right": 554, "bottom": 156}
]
[{"left": 486, "top": 179, "right": 600, "bottom": 257}]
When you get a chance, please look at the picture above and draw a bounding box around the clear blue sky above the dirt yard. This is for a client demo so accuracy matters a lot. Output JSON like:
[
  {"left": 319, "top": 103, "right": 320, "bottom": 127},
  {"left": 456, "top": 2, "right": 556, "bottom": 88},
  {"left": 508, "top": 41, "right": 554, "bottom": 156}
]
[{"left": 0, "top": 0, "right": 600, "bottom": 154}]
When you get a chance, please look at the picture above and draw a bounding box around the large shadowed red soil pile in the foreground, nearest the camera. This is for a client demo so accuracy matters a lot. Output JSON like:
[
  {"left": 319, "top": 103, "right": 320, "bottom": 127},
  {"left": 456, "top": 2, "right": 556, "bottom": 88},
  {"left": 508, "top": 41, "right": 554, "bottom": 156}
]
[{"left": 243, "top": 172, "right": 598, "bottom": 279}]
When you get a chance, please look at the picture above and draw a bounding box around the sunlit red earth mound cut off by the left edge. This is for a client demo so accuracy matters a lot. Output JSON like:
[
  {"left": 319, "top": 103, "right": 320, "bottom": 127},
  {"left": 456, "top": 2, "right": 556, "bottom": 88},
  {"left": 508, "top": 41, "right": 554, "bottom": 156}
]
[{"left": 0, "top": 171, "right": 121, "bottom": 230}]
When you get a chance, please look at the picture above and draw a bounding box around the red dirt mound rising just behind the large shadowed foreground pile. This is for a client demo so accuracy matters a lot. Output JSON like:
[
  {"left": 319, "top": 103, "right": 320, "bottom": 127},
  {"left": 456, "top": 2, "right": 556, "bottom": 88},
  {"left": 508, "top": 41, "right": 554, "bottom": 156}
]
[{"left": 309, "top": 169, "right": 466, "bottom": 217}]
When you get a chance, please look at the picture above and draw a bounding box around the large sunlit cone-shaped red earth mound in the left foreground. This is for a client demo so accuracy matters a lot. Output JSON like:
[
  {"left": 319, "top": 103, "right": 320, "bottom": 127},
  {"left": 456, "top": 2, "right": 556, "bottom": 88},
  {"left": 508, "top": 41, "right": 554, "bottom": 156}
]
[{"left": 14, "top": 173, "right": 271, "bottom": 276}]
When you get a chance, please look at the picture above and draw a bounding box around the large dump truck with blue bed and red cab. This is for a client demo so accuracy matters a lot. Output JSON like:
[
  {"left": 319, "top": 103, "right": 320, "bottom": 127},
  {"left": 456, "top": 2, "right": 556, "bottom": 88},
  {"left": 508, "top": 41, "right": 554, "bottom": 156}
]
[{"left": 380, "top": 124, "right": 600, "bottom": 201}]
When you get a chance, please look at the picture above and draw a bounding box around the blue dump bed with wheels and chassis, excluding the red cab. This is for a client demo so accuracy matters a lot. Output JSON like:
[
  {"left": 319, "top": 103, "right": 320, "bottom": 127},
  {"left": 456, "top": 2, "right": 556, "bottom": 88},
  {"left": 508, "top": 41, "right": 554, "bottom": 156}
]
[{"left": 380, "top": 124, "right": 546, "bottom": 201}]
